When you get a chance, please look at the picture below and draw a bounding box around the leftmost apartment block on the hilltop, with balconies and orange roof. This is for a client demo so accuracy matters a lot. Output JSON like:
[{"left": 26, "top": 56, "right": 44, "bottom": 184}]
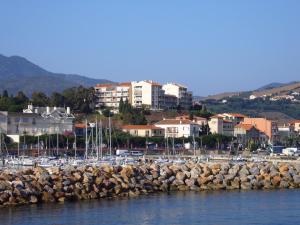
[{"left": 95, "top": 82, "right": 131, "bottom": 112}]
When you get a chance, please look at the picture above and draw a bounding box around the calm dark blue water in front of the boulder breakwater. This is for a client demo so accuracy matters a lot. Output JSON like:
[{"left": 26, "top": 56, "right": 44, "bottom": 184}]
[{"left": 0, "top": 190, "right": 300, "bottom": 225}]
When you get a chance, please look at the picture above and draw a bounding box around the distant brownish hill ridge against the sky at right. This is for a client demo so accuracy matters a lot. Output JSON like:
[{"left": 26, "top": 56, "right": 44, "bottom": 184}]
[{"left": 203, "top": 81, "right": 300, "bottom": 100}]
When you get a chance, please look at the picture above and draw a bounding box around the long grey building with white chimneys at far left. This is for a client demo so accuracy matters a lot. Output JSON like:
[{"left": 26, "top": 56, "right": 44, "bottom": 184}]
[{"left": 0, "top": 105, "right": 74, "bottom": 140}]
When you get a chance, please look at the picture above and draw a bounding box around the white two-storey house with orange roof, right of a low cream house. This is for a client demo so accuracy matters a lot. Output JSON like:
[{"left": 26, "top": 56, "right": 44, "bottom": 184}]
[{"left": 155, "top": 119, "right": 200, "bottom": 138}]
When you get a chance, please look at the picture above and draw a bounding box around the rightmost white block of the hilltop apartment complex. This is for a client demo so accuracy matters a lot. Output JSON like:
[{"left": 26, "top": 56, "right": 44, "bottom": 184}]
[{"left": 162, "top": 83, "right": 192, "bottom": 109}]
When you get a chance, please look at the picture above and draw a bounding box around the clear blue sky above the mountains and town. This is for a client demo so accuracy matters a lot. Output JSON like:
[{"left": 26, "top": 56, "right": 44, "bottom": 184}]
[{"left": 0, "top": 0, "right": 300, "bottom": 95}]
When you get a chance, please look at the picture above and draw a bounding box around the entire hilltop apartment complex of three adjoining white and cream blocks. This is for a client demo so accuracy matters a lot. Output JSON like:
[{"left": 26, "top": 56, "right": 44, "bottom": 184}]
[{"left": 95, "top": 80, "right": 192, "bottom": 112}]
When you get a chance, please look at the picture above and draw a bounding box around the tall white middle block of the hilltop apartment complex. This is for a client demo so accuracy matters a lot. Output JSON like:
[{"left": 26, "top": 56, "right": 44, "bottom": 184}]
[{"left": 131, "top": 80, "right": 165, "bottom": 110}]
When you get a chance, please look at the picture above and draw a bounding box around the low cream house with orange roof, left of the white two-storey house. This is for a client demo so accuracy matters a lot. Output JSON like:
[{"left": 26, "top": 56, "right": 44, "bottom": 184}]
[{"left": 122, "top": 125, "right": 165, "bottom": 137}]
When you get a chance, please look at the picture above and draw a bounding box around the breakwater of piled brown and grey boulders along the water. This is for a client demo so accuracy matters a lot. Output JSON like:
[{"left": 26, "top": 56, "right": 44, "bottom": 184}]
[{"left": 0, "top": 162, "right": 300, "bottom": 206}]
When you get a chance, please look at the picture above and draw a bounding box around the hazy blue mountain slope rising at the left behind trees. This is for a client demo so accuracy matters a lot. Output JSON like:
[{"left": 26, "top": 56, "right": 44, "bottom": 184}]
[{"left": 0, "top": 54, "right": 112, "bottom": 96}]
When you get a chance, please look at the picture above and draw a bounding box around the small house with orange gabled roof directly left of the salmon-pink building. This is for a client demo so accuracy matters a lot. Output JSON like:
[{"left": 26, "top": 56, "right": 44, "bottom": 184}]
[{"left": 234, "top": 123, "right": 261, "bottom": 145}]
